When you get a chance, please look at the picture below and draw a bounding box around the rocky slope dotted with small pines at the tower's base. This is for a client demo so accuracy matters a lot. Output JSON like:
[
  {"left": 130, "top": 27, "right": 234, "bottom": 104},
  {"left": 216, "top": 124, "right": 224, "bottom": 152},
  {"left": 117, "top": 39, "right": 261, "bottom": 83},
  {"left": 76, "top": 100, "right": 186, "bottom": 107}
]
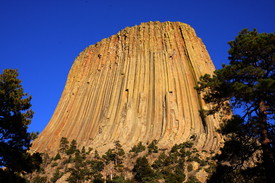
[{"left": 27, "top": 136, "right": 212, "bottom": 183}]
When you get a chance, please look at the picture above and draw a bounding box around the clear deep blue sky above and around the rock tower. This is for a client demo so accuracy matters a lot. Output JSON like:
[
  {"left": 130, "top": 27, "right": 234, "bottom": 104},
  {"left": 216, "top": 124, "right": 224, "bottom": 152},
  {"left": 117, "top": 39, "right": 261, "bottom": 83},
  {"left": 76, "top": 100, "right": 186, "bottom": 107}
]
[{"left": 0, "top": 0, "right": 275, "bottom": 132}]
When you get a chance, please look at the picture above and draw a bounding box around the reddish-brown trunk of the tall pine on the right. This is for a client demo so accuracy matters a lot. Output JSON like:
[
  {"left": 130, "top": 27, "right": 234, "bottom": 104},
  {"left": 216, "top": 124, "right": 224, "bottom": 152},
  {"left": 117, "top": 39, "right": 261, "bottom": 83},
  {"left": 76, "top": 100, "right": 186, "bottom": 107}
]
[{"left": 259, "top": 99, "right": 275, "bottom": 183}]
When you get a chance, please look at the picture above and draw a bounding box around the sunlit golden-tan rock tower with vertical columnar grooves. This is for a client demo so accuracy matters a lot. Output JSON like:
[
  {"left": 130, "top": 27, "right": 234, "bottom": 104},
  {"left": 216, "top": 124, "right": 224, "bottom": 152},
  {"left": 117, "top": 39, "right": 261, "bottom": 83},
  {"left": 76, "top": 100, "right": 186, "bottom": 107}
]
[{"left": 32, "top": 22, "right": 221, "bottom": 154}]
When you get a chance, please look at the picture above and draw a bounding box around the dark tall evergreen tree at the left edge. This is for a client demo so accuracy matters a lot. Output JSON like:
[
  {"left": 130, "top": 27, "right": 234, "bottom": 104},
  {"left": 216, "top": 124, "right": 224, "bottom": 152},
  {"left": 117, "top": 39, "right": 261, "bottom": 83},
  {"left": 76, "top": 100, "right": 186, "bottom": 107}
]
[{"left": 0, "top": 69, "right": 42, "bottom": 177}]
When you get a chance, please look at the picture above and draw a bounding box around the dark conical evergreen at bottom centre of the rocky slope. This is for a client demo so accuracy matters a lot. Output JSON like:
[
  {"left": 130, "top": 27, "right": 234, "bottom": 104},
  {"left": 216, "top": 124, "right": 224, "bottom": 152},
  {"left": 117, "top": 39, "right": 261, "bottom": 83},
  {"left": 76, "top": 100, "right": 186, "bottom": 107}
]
[{"left": 133, "top": 156, "right": 155, "bottom": 182}]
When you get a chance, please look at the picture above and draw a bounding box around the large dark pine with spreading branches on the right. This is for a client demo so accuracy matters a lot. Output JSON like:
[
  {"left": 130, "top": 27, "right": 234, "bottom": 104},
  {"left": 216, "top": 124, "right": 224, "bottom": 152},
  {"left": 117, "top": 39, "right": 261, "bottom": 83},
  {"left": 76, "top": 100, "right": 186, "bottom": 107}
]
[{"left": 196, "top": 29, "right": 275, "bottom": 182}]
